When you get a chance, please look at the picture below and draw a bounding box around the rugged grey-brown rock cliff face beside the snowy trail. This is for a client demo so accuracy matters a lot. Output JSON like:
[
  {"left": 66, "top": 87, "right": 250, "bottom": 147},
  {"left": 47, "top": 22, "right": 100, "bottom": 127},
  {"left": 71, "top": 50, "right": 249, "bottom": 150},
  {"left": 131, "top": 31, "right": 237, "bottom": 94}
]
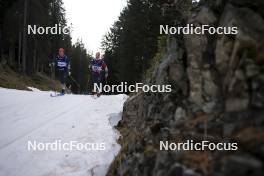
[{"left": 109, "top": 0, "right": 264, "bottom": 176}]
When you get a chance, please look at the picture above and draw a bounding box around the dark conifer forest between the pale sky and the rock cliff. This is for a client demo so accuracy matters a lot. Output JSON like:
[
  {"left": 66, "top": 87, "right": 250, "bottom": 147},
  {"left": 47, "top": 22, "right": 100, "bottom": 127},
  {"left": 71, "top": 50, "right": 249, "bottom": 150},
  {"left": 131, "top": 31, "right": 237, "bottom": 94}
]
[{"left": 102, "top": 0, "right": 197, "bottom": 84}]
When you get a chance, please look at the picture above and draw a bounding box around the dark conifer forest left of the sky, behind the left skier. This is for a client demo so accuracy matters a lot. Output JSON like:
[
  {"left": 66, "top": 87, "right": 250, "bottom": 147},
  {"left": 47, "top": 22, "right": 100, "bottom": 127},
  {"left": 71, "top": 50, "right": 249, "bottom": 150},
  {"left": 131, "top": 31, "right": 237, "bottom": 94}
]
[{"left": 0, "top": 0, "right": 92, "bottom": 93}]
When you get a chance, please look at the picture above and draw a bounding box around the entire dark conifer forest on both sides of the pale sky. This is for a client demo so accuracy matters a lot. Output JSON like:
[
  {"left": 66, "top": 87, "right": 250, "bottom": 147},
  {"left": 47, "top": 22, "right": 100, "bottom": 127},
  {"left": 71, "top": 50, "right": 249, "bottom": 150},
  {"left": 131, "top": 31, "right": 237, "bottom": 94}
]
[{"left": 0, "top": 0, "right": 195, "bottom": 93}]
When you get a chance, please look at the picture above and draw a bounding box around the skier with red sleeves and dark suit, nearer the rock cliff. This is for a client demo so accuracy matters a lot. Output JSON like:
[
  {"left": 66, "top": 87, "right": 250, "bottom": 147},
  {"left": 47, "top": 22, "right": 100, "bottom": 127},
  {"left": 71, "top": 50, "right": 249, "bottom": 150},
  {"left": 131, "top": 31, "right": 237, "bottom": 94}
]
[{"left": 89, "top": 52, "right": 108, "bottom": 96}]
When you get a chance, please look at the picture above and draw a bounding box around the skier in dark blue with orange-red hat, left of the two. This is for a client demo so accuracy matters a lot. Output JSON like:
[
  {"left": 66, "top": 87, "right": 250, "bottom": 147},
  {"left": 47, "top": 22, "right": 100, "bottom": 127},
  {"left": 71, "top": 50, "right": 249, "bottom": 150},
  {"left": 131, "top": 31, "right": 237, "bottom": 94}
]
[{"left": 55, "top": 48, "right": 71, "bottom": 95}]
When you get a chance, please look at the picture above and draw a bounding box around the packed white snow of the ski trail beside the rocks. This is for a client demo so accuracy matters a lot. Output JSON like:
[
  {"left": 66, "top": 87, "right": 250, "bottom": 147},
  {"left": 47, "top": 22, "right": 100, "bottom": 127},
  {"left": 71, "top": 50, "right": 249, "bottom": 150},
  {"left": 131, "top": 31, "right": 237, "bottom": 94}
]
[{"left": 0, "top": 88, "right": 127, "bottom": 176}]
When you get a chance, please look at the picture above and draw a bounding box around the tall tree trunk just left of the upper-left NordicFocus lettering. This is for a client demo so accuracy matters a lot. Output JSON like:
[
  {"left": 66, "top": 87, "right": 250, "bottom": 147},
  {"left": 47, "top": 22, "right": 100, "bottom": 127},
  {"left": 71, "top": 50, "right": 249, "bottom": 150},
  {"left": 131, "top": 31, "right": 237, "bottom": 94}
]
[{"left": 22, "top": 0, "right": 28, "bottom": 73}]
